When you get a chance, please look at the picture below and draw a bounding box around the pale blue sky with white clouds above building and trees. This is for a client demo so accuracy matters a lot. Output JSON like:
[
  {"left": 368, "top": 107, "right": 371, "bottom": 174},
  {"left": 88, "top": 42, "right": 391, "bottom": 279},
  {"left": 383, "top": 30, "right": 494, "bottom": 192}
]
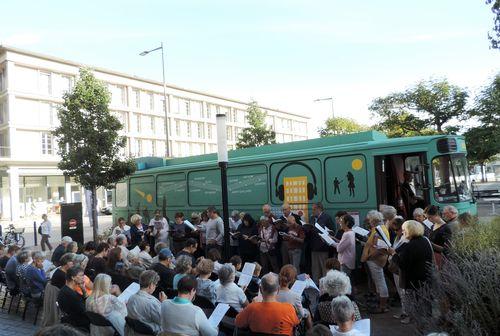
[{"left": 0, "top": 0, "right": 500, "bottom": 136}]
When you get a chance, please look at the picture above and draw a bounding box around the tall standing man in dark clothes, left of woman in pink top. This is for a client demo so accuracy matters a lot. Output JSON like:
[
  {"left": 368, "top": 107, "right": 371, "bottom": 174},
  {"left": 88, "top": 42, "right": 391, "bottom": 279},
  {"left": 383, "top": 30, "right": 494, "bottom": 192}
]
[{"left": 309, "top": 202, "right": 335, "bottom": 283}]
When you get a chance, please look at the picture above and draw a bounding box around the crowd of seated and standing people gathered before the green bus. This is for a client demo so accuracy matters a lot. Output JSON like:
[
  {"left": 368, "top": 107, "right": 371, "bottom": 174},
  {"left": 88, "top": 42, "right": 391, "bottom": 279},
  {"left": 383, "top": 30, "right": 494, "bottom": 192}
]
[{"left": 0, "top": 203, "right": 471, "bottom": 335}]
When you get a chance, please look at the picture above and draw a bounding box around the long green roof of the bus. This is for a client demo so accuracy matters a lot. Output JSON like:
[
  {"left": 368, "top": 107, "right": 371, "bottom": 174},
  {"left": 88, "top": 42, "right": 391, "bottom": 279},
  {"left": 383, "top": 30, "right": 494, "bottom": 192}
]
[{"left": 136, "top": 131, "right": 458, "bottom": 173}]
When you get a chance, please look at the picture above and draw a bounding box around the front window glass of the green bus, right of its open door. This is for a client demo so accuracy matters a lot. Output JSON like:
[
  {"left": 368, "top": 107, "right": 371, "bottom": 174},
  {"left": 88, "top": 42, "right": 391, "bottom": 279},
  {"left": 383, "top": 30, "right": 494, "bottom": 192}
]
[{"left": 432, "top": 154, "right": 471, "bottom": 203}]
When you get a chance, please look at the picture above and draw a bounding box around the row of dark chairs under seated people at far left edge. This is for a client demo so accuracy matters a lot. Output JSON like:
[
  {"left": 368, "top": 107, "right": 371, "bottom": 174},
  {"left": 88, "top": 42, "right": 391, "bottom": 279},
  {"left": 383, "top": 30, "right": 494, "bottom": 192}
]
[{"left": 0, "top": 270, "right": 43, "bottom": 325}]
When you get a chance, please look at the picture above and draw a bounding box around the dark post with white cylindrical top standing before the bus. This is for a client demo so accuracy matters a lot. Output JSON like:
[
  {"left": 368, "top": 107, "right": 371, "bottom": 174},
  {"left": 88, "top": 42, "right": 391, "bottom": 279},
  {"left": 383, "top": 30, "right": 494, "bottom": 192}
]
[{"left": 216, "top": 113, "right": 231, "bottom": 261}]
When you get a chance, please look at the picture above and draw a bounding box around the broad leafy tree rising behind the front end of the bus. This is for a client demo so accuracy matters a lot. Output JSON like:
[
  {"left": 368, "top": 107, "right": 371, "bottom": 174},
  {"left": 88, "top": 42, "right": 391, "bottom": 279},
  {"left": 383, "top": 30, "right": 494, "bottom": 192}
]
[{"left": 369, "top": 79, "right": 468, "bottom": 137}]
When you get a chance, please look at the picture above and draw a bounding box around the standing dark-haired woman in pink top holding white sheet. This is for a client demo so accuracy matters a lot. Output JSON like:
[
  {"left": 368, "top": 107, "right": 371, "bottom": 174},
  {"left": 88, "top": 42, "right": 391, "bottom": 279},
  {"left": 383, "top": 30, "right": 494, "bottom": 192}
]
[{"left": 336, "top": 215, "right": 356, "bottom": 275}]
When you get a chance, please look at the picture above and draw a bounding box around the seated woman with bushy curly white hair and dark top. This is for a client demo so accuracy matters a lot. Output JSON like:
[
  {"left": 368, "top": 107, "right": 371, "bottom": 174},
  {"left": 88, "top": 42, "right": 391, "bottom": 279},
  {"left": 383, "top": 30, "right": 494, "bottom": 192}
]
[{"left": 314, "top": 270, "right": 361, "bottom": 324}]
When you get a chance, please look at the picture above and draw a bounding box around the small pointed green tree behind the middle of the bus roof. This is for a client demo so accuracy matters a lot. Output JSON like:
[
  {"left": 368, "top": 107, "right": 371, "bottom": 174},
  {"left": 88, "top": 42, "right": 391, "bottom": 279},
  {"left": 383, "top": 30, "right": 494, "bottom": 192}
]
[{"left": 236, "top": 101, "right": 276, "bottom": 148}]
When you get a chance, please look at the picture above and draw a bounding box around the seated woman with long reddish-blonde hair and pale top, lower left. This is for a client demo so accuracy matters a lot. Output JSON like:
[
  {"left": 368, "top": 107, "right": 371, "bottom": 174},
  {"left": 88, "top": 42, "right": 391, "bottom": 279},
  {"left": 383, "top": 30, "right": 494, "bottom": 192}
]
[{"left": 85, "top": 274, "right": 127, "bottom": 336}]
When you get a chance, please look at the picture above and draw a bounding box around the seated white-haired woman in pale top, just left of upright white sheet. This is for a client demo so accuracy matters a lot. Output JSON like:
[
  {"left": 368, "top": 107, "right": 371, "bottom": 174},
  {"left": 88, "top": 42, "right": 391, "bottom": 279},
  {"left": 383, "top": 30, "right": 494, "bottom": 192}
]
[{"left": 217, "top": 264, "right": 248, "bottom": 311}]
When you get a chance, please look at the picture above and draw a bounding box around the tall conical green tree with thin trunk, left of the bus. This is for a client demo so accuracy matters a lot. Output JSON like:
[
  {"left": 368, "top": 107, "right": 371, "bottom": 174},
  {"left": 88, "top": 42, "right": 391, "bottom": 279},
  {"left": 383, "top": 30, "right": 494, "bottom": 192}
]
[{"left": 53, "top": 69, "right": 135, "bottom": 239}]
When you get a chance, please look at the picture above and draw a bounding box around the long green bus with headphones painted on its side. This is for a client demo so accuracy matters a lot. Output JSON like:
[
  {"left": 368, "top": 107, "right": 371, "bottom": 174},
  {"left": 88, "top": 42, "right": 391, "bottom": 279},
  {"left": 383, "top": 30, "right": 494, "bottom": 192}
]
[{"left": 113, "top": 131, "right": 477, "bottom": 226}]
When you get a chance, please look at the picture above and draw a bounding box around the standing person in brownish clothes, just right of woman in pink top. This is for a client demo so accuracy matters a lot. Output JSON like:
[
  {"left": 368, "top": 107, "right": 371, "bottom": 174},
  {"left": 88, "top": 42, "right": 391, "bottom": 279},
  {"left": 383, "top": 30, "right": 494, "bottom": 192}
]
[{"left": 361, "top": 210, "right": 391, "bottom": 314}]
